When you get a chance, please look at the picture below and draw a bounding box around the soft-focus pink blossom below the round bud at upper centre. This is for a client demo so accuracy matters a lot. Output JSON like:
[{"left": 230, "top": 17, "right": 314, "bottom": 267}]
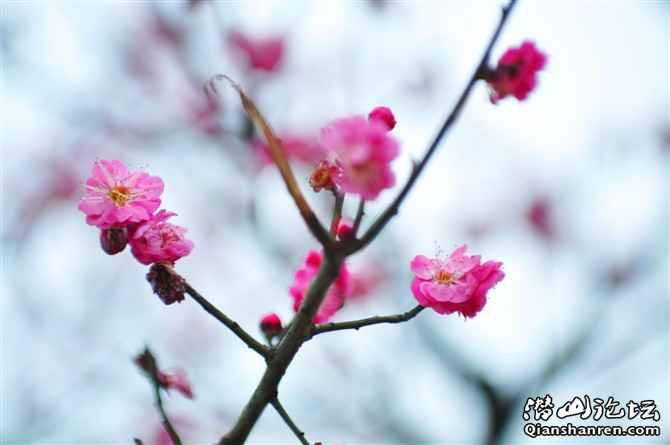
[{"left": 321, "top": 116, "right": 399, "bottom": 200}]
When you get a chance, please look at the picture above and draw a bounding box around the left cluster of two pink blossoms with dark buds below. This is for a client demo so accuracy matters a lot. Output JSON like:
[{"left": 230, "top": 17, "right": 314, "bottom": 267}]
[{"left": 79, "top": 159, "right": 193, "bottom": 304}]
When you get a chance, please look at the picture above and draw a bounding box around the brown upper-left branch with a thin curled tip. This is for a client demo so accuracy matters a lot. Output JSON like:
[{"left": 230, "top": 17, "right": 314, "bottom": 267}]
[{"left": 208, "top": 74, "right": 331, "bottom": 249}]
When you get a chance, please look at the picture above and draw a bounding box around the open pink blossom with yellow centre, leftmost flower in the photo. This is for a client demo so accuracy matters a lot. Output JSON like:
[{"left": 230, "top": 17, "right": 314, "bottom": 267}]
[{"left": 79, "top": 160, "right": 163, "bottom": 229}]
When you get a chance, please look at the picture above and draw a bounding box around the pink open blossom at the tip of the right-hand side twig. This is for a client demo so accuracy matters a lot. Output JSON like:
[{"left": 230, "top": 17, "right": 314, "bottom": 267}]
[{"left": 410, "top": 245, "right": 505, "bottom": 317}]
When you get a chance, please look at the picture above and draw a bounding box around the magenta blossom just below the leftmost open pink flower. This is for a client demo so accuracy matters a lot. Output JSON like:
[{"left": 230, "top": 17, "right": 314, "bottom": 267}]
[{"left": 130, "top": 210, "right": 193, "bottom": 264}]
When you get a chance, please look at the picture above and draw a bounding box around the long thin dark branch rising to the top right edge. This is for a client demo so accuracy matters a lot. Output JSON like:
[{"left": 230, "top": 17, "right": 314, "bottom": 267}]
[{"left": 346, "top": 0, "right": 516, "bottom": 254}]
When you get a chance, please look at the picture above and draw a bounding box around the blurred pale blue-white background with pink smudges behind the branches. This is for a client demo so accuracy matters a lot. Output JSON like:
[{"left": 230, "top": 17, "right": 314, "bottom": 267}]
[{"left": 0, "top": 0, "right": 670, "bottom": 445}]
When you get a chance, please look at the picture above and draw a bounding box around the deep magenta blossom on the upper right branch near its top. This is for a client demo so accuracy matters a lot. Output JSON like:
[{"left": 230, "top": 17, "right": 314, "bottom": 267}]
[{"left": 484, "top": 41, "right": 547, "bottom": 104}]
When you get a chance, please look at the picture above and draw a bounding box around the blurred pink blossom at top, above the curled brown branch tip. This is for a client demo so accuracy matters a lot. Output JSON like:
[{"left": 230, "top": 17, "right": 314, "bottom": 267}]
[{"left": 228, "top": 31, "right": 285, "bottom": 73}]
